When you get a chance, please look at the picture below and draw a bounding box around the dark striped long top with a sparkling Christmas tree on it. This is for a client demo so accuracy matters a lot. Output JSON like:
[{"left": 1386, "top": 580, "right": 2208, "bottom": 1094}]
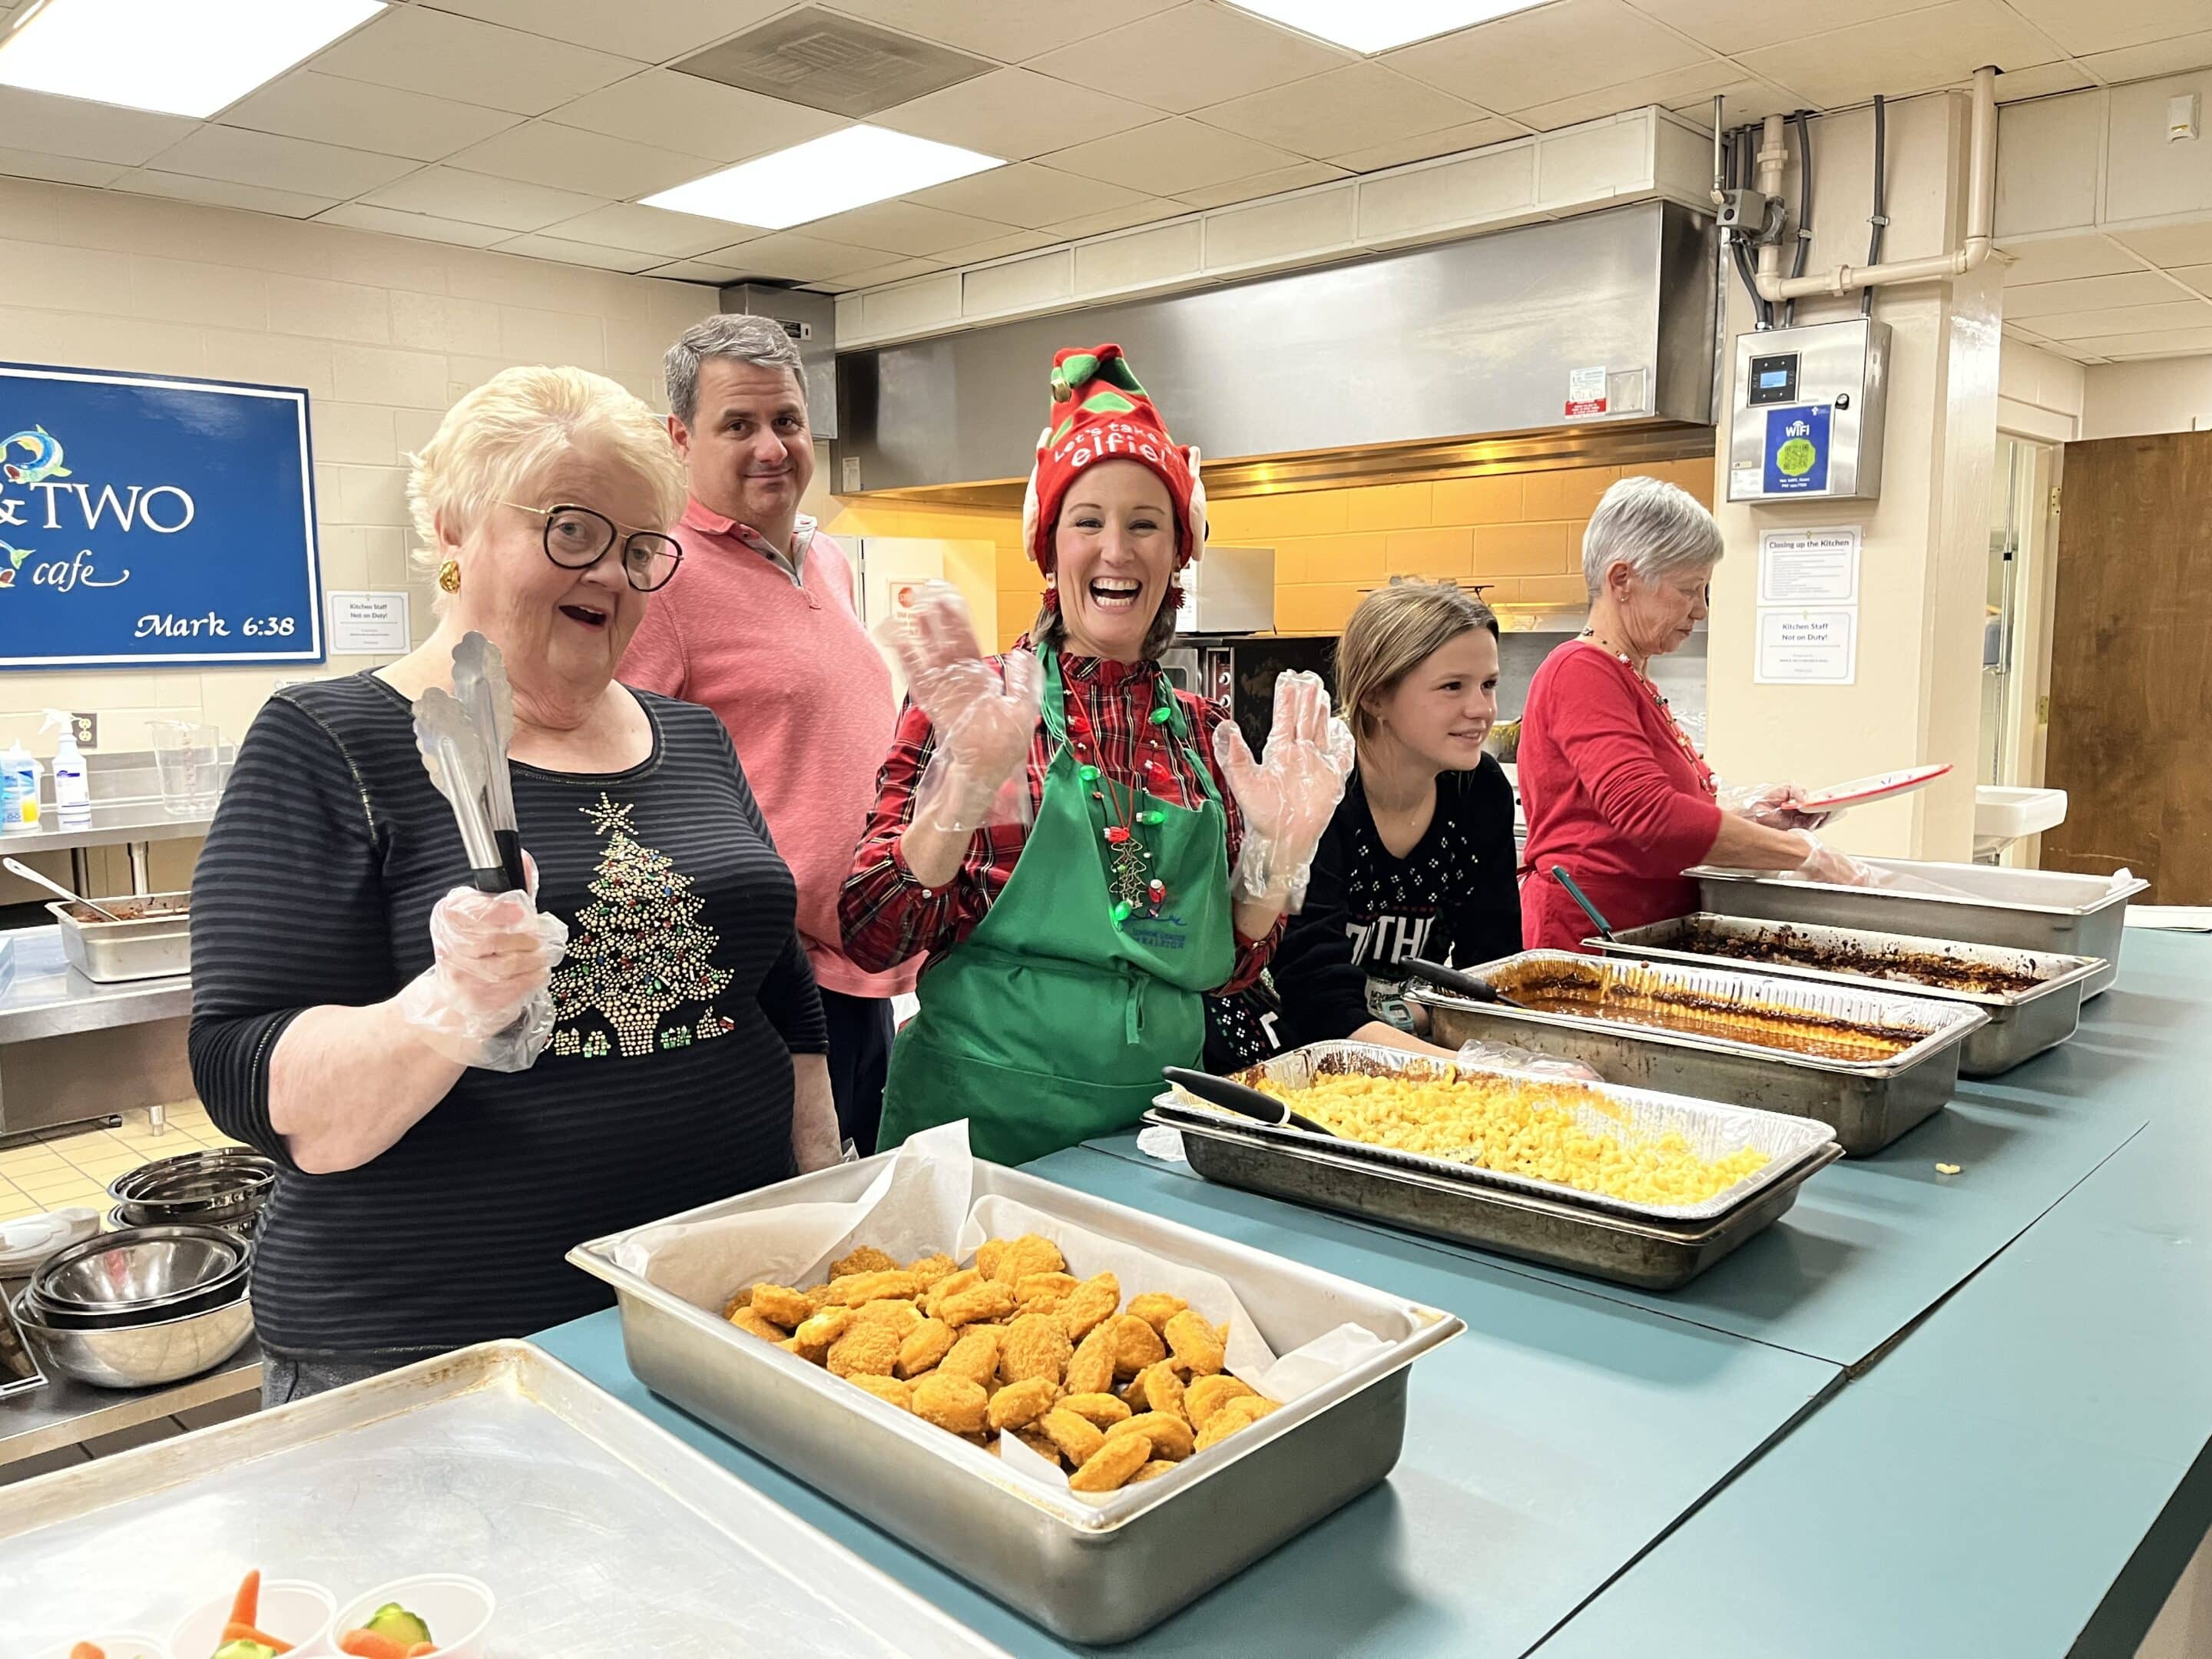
[{"left": 193, "top": 674, "right": 825, "bottom": 1363}]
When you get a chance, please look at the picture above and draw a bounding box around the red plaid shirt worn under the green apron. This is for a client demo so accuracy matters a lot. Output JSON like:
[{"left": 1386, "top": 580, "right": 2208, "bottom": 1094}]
[{"left": 839, "top": 641, "right": 1283, "bottom": 993}]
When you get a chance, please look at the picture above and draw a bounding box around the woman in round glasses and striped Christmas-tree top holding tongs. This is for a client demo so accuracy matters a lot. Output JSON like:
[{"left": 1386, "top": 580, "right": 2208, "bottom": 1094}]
[{"left": 190, "top": 367, "right": 839, "bottom": 1402}]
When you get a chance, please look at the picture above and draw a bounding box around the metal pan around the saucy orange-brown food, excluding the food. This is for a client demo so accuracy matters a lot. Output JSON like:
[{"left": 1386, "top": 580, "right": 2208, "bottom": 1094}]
[{"left": 1407, "top": 951, "right": 1988, "bottom": 1154}]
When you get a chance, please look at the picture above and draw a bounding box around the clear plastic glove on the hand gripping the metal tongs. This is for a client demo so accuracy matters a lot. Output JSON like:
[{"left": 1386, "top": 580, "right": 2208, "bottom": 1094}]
[{"left": 398, "top": 882, "right": 568, "bottom": 1071}]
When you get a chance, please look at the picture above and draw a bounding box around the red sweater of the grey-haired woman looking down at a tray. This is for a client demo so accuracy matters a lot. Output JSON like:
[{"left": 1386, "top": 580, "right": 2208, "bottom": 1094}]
[{"left": 1520, "top": 639, "right": 1721, "bottom": 951}]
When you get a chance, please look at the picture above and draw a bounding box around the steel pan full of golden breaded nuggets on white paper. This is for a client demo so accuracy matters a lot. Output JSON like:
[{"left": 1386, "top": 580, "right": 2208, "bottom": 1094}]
[{"left": 568, "top": 1126, "right": 1465, "bottom": 1644}]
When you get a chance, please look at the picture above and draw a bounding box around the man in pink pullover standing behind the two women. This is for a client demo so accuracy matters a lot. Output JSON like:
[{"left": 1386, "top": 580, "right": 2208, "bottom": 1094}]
[{"left": 619, "top": 316, "right": 920, "bottom": 1154}]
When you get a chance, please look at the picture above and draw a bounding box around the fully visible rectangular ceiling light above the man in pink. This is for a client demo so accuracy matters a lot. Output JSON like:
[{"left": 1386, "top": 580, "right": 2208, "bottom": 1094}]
[{"left": 646, "top": 126, "right": 1006, "bottom": 230}]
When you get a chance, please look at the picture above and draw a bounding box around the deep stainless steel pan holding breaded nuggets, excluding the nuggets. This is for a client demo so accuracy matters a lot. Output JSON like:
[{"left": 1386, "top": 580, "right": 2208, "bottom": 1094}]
[{"left": 568, "top": 1152, "right": 1465, "bottom": 1644}]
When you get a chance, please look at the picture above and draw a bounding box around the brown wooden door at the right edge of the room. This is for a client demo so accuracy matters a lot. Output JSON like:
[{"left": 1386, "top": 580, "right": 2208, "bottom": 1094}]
[{"left": 2044, "top": 432, "right": 2212, "bottom": 905}]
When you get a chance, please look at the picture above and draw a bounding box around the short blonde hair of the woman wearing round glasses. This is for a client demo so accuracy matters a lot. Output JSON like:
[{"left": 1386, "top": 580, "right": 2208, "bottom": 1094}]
[{"left": 407, "top": 367, "right": 690, "bottom": 604}]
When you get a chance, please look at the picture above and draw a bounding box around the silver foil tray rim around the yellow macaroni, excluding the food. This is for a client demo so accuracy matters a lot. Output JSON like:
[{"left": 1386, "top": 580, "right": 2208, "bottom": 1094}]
[{"left": 1152, "top": 1041, "right": 1836, "bottom": 1224}]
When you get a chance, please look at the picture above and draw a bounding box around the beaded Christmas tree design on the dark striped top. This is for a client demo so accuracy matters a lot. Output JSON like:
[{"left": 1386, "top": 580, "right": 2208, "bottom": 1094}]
[{"left": 553, "top": 790, "right": 734, "bottom": 1060}]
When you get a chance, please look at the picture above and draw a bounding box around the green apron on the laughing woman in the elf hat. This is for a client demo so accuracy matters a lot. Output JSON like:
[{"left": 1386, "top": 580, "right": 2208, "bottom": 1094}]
[{"left": 876, "top": 651, "right": 1237, "bottom": 1164}]
